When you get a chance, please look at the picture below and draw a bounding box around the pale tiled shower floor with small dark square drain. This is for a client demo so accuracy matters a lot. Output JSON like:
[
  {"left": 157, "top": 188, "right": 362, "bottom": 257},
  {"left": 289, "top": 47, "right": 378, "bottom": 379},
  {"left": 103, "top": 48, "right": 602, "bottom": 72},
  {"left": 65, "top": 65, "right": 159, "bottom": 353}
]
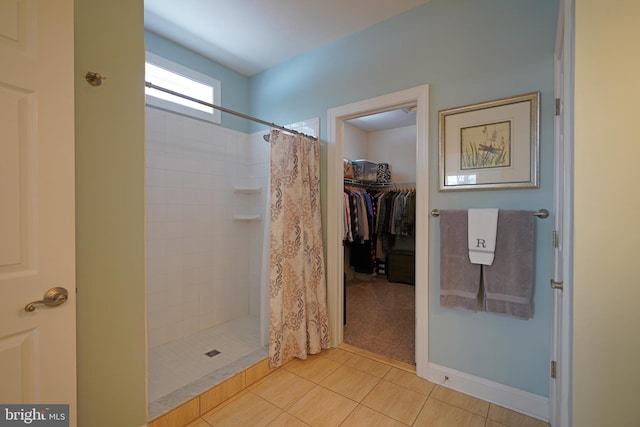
[{"left": 148, "top": 316, "right": 268, "bottom": 419}]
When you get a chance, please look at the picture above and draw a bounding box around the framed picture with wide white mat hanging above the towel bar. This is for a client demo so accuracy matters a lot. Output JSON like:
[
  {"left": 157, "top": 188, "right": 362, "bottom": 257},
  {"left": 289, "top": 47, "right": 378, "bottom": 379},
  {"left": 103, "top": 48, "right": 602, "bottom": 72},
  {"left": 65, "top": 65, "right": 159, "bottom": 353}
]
[{"left": 438, "top": 92, "right": 540, "bottom": 191}]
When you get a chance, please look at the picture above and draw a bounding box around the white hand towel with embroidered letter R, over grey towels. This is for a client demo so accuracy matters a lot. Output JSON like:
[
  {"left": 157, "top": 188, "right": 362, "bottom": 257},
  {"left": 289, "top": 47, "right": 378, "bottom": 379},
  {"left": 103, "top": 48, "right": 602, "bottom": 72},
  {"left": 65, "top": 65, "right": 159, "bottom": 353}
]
[{"left": 468, "top": 209, "right": 498, "bottom": 265}]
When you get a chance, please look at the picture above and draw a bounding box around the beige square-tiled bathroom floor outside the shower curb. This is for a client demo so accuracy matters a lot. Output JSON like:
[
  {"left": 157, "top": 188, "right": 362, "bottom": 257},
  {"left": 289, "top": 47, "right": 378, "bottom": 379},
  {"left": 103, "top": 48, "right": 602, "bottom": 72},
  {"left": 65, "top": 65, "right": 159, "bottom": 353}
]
[{"left": 181, "top": 348, "right": 549, "bottom": 427}]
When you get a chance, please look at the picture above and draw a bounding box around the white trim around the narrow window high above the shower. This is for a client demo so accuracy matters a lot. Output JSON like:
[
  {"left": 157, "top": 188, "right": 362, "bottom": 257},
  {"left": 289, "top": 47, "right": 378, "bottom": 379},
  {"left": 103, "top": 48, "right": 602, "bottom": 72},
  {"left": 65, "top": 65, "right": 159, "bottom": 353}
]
[{"left": 145, "top": 52, "right": 221, "bottom": 124}]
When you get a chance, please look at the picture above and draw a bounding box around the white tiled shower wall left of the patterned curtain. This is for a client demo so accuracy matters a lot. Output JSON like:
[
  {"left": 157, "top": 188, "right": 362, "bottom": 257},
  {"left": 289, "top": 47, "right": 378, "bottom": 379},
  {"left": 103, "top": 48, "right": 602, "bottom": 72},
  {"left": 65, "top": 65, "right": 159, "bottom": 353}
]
[{"left": 146, "top": 108, "right": 268, "bottom": 348}]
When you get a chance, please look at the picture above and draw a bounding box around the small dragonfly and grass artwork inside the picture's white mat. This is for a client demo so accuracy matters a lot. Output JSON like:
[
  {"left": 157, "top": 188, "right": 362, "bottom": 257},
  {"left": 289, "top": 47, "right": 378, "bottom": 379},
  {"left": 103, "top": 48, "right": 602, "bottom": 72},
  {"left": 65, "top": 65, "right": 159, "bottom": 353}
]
[{"left": 460, "top": 121, "right": 511, "bottom": 170}]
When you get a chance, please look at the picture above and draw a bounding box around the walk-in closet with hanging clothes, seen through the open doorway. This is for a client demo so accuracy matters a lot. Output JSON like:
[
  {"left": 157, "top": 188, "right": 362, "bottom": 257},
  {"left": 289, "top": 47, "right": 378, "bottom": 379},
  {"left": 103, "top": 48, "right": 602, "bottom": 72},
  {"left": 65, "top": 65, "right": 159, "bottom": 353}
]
[{"left": 343, "top": 108, "right": 416, "bottom": 364}]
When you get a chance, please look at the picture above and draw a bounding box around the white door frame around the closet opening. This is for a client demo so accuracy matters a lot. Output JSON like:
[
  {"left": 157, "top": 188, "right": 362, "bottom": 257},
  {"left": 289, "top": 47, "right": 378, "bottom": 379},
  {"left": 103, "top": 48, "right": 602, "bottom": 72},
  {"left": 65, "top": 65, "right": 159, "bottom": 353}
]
[{"left": 326, "top": 85, "right": 429, "bottom": 378}]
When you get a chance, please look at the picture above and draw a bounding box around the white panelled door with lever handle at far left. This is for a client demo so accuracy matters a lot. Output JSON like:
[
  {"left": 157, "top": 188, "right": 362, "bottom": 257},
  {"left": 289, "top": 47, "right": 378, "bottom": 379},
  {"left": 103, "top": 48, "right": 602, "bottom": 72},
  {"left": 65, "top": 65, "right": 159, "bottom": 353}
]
[{"left": 0, "top": 0, "right": 76, "bottom": 426}]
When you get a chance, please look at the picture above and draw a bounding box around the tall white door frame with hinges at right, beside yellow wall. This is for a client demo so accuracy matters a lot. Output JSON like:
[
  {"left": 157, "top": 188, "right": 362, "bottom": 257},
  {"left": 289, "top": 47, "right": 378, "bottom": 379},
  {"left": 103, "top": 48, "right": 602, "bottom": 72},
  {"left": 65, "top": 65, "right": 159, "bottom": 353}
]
[{"left": 549, "top": 0, "right": 574, "bottom": 427}]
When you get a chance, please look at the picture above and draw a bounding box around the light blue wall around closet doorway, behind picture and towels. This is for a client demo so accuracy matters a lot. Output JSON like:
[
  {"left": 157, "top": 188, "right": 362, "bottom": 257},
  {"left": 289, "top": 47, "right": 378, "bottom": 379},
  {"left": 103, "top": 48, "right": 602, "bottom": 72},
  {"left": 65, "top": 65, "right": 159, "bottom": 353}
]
[{"left": 250, "top": 0, "right": 558, "bottom": 396}]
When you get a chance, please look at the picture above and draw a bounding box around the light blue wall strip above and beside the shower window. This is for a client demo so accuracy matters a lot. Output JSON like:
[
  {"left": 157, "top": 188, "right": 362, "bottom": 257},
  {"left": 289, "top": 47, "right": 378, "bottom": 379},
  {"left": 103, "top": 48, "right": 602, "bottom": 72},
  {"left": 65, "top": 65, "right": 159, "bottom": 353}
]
[{"left": 144, "top": 30, "right": 251, "bottom": 132}]
